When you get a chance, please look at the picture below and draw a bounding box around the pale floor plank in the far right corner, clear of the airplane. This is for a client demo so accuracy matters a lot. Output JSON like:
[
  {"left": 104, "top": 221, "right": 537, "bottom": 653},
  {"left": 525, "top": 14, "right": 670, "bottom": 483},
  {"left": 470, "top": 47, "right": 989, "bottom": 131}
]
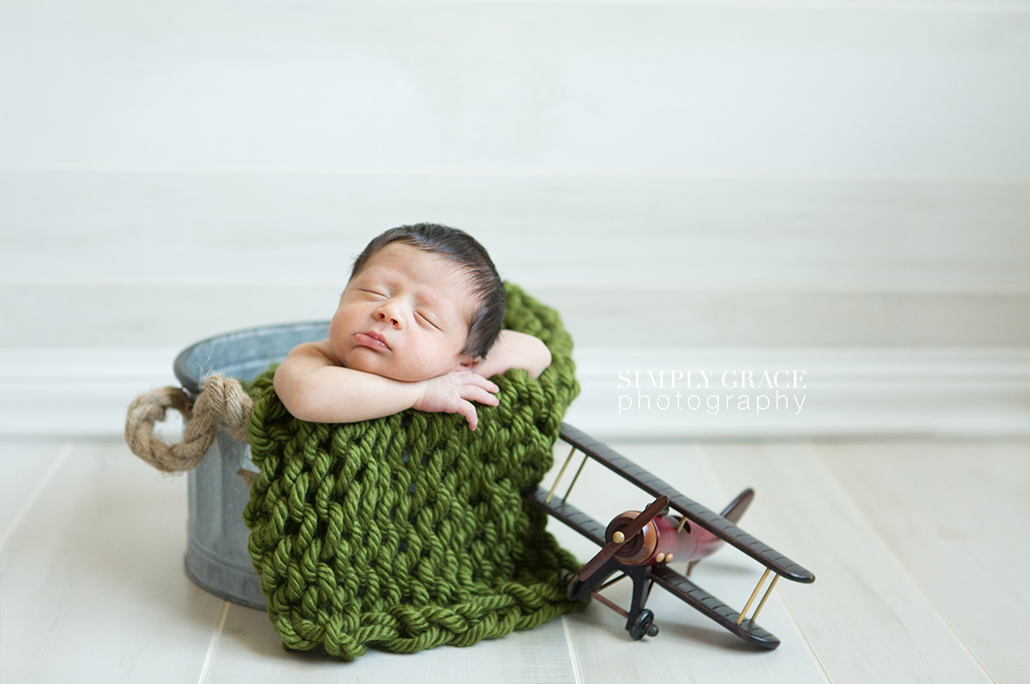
[{"left": 815, "top": 440, "right": 1030, "bottom": 683}]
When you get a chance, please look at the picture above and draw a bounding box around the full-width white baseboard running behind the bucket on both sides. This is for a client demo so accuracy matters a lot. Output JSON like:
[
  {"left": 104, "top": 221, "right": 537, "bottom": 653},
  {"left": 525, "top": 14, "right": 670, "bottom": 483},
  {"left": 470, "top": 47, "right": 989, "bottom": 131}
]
[{"left": 0, "top": 347, "right": 1030, "bottom": 440}]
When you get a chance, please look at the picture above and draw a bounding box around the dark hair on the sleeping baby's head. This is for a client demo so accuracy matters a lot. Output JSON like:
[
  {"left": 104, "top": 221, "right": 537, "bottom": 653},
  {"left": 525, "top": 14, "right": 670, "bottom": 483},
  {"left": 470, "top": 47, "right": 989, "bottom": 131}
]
[{"left": 350, "top": 224, "right": 505, "bottom": 358}]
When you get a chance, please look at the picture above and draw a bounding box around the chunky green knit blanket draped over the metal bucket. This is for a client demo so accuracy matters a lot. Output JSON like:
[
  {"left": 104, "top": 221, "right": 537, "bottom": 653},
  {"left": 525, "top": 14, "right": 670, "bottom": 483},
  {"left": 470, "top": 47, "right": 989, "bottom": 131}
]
[{"left": 243, "top": 284, "right": 583, "bottom": 660}]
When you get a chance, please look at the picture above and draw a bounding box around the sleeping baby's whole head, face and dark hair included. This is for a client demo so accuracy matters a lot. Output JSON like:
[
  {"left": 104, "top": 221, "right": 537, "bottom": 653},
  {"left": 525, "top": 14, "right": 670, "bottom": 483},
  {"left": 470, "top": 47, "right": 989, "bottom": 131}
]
[{"left": 330, "top": 224, "right": 505, "bottom": 381}]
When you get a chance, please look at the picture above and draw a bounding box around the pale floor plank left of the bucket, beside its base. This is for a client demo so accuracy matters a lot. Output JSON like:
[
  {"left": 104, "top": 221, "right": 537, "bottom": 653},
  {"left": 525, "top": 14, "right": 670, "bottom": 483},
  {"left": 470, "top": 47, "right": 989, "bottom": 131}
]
[{"left": 0, "top": 440, "right": 221, "bottom": 684}]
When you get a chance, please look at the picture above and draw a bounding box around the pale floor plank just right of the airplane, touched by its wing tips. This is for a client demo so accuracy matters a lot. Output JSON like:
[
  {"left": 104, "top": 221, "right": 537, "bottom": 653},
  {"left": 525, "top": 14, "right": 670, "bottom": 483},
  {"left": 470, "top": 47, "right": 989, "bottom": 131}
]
[{"left": 702, "top": 444, "right": 986, "bottom": 684}]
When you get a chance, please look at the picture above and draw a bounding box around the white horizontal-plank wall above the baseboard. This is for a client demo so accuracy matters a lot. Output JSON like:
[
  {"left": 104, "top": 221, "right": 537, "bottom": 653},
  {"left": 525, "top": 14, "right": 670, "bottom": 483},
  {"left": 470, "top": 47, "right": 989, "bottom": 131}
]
[{"left": 0, "top": 0, "right": 1030, "bottom": 432}]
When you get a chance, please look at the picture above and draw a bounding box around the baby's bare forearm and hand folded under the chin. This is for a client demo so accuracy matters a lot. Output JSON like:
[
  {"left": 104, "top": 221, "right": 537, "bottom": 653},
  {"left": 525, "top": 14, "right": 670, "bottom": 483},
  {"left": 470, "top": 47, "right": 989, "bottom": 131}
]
[{"left": 273, "top": 340, "right": 497, "bottom": 430}]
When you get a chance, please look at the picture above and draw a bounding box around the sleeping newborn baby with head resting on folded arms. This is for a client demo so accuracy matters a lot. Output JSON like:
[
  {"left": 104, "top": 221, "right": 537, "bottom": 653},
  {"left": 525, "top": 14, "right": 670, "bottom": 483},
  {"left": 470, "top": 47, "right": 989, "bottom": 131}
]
[{"left": 274, "top": 224, "right": 551, "bottom": 430}]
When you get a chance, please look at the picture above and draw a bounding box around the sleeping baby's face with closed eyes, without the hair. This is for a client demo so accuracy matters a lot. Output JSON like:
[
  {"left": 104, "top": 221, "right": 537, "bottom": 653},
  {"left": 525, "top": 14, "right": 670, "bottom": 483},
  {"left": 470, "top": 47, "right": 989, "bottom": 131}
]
[{"left": 329, "top": 242, "right": 476, "bottom": 382}]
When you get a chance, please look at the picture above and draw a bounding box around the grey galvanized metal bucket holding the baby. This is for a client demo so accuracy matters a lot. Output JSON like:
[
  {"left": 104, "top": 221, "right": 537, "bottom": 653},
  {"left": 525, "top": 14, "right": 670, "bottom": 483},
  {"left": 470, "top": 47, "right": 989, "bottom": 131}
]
[{"left": 175, "top": 321, "right": 329, "bottom": 610}]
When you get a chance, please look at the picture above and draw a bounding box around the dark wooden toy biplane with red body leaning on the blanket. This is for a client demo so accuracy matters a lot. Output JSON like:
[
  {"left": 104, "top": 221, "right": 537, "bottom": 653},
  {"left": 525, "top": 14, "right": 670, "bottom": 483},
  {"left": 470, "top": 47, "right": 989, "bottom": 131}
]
[{"left": 530, "top": 423, "right": 816, "bottom": 649}]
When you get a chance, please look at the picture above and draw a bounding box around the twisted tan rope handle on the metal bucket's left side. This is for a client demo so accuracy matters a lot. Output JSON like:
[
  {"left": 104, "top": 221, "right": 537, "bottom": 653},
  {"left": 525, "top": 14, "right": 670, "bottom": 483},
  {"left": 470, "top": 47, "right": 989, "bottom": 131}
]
[{"left": 126, "top": 375, "right": 253, "bottom": 473}]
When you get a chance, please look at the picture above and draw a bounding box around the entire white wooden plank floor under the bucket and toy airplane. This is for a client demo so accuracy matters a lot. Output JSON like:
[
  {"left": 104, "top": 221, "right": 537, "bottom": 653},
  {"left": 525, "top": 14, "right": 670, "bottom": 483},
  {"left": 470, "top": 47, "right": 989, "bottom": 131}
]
[{"left": 0, "top": 437, "right": 1030, "bottom": 684}]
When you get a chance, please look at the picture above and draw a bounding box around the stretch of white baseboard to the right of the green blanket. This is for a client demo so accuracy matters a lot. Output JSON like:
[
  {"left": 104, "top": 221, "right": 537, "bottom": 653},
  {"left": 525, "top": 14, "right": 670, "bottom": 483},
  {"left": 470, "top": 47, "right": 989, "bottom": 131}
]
[{"left": 567, "top": 347, "right": 1030, "bottom": 440}]
